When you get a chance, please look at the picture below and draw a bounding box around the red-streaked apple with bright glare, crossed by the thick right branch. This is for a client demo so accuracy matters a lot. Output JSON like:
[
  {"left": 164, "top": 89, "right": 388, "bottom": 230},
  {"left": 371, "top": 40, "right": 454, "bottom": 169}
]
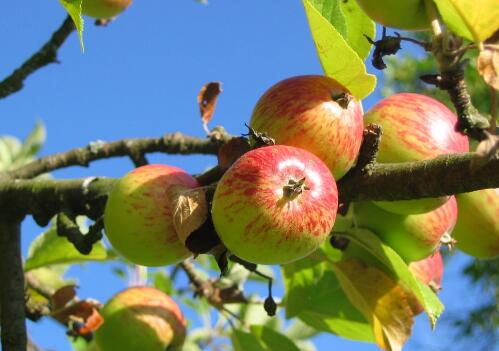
[{"left": 364, "top": 93, "right": 469, "bottom": 214}]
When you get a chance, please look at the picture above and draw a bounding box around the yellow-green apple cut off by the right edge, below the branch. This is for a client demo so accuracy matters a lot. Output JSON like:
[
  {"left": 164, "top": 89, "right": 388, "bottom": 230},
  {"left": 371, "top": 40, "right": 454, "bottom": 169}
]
[{"left": 453, "top": 188, "right": 499, "bottom": 259}]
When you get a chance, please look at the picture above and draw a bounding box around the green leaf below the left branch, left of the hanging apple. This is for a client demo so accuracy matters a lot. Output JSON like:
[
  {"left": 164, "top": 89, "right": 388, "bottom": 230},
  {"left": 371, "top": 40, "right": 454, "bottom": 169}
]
[{"left": 24, "top": 225, "right": 114, "bottom": 271}]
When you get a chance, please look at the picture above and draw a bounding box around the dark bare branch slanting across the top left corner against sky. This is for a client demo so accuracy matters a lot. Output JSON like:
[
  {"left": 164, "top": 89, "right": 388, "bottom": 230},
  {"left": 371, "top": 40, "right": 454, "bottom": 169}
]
[{"left": 0, "top": 16, "right": 75, "bottom": 99}]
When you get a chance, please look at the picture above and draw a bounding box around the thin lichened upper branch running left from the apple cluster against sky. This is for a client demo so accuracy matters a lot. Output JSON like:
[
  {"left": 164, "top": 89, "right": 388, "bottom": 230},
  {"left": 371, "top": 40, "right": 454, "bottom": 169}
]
[{"left": 7, "top": 132, "right": 229, "bottom": 179}]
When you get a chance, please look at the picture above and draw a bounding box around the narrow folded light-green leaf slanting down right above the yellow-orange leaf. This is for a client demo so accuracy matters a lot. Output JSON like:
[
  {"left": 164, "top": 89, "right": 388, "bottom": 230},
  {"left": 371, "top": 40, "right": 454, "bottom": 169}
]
[{"left": 337, "top": 228, "right": 444, "bottom": 327}]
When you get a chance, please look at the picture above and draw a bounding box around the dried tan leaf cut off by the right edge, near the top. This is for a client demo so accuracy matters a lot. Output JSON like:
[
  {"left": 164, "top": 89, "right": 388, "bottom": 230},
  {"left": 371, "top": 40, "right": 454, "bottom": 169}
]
[{"left": 477, "top": 31, "right": 499, "bottom": 90}]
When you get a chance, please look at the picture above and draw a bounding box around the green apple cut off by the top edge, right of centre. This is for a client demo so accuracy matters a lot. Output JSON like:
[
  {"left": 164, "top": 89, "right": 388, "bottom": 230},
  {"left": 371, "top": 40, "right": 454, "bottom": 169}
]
[{"left": 357, "top": 0, "right": 430, "bottom": 30}]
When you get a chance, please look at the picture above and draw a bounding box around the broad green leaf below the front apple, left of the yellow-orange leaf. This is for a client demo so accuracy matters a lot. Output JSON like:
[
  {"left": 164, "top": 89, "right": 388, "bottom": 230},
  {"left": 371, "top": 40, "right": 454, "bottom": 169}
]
[{"left": 282, "top": 258, "right": 374, "bottom": 342}]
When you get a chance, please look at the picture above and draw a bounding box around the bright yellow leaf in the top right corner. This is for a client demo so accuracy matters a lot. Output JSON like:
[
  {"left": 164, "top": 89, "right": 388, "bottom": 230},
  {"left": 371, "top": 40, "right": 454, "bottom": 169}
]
[{"left": 448, "top": 0, "right": 499, "bottom": 42}]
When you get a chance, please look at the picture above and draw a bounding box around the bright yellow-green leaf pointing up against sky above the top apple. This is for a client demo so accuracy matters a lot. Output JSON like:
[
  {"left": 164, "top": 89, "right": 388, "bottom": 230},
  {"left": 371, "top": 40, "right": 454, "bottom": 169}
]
[{"left": 303, "top": 0, "right": 376, "bottom": 99}]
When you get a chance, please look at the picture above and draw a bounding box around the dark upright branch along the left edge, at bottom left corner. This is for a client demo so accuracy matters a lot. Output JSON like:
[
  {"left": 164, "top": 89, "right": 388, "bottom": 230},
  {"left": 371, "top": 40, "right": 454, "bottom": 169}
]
[{"left": 0, "top": 216, "right": 27, "bottom": 351}]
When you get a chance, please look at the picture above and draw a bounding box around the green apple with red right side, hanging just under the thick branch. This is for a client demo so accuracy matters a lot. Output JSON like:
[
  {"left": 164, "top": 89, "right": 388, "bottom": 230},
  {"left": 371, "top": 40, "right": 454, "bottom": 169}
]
[{"left": 354, "top": 196, "right": 458, "bottom": 262}]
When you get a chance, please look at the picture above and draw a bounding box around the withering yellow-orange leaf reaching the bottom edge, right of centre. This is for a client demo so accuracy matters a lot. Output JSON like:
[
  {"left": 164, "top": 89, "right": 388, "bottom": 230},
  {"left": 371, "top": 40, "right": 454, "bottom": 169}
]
[{"left": 333, "top": 259, "right": 413, "bottom": 351}]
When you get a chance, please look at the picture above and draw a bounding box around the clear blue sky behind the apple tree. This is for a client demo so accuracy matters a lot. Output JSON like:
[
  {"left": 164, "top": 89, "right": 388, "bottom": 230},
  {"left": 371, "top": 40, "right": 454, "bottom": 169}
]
[{"left": 0, "top": 0, "right": 492, "bottom": 351}]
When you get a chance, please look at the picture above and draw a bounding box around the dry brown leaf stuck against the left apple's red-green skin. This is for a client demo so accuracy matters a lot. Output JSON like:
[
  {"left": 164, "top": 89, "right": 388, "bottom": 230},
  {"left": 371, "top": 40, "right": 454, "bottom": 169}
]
[{"left": 170, "top": 186, "right": 208, "bottom": 244}]
